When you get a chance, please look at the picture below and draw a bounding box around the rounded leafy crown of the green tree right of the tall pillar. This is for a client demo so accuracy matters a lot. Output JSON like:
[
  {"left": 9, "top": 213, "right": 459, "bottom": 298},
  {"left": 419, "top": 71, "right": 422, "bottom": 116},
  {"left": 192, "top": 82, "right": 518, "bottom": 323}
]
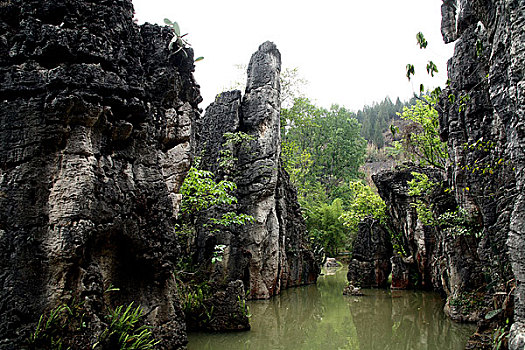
[{"left": 281, "top": 98, "right": 366, "bottom": 193}]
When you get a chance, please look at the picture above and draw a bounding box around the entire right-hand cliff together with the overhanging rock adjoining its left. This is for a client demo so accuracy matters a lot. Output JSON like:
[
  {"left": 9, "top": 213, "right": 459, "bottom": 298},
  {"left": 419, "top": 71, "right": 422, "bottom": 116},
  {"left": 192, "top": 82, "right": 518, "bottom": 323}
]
[{"left": 352, "top": 0, "right": 525, "bottom": 349}]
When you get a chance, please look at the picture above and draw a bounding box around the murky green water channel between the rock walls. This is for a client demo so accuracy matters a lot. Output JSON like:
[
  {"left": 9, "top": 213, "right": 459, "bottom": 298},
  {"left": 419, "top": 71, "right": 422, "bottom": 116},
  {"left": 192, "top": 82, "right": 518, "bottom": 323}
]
[{"left": 188, "top": 269, "right": 475, "bottom": 350}]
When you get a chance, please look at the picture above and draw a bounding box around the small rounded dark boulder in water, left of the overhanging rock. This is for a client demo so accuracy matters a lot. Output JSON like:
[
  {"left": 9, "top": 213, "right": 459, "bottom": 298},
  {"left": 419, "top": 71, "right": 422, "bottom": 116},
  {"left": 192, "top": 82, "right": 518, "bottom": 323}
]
[{"left": 347, "top": 219, "right": 392, "bottom": 288}]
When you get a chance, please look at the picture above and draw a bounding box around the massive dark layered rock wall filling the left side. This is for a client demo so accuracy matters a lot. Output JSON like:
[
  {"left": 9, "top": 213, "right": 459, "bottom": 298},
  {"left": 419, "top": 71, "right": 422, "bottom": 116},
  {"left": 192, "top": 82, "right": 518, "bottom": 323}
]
[{"left": 0, "top": 0, "right": 201, "bottom": 349}]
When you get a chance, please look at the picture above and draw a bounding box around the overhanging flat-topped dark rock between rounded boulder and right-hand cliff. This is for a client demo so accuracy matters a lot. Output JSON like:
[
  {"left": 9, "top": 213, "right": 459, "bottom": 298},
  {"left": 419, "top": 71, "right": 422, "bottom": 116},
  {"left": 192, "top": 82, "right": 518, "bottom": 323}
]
[{"left": 372, "top": 165, "right": 486, "bottom": 321}]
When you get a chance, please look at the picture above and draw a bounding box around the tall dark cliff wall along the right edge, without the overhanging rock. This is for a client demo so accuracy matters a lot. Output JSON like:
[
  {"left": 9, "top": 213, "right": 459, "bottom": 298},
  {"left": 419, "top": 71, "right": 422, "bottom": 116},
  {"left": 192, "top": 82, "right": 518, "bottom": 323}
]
[{"left": 440, "top": 0, "right": 525, "bottom": 349}]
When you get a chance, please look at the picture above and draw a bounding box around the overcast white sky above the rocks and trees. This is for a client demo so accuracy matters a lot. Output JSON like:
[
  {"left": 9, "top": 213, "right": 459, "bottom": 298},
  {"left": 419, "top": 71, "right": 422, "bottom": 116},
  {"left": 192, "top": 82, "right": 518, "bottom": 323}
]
[{"left": 133, "top": 0, "right": 453, "bottom": 110}]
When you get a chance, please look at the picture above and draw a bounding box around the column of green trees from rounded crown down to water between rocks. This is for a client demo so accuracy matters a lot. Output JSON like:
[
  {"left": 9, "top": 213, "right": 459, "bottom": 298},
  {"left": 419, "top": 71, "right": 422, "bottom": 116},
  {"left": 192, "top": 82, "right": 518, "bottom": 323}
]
[{"left": 281, "top": 98, "right": 366, "bottom": 256}]
